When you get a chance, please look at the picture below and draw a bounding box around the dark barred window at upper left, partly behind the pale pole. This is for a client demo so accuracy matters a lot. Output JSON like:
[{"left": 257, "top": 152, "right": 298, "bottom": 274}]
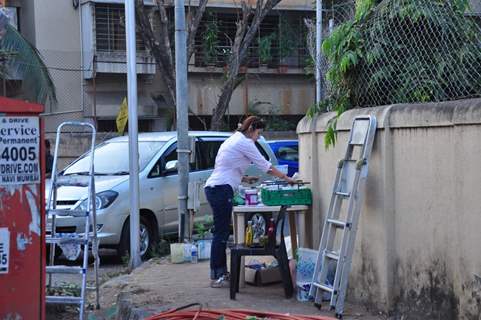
[{"left": 95, "top": 3, "right": 145, "bottom": 52}]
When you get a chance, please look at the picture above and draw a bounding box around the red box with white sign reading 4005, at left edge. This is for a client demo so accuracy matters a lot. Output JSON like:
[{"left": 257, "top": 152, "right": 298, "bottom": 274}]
[{"left": 0, "top": 97, "right": 45, "bottom": 319}]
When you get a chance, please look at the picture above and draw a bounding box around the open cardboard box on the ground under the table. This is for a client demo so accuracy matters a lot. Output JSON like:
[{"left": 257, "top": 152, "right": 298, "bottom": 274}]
[{"left": 245, "top": 256, "right": 282, "bottom": 286}]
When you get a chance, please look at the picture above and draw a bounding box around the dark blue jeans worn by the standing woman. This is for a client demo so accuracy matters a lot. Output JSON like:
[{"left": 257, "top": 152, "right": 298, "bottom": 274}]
[{"left": 205, "top": 184, "right": 234, "bottom": 279}]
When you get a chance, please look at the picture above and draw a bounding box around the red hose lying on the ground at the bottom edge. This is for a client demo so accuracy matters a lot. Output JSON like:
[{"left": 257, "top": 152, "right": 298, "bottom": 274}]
[{"left": 147, "top": 304, "right": 333, "bottom": 320}]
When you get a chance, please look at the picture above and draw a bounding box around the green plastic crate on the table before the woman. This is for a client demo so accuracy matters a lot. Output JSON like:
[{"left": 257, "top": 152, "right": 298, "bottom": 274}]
[{"left": 261, "top": 188, "right": 312, "bottom": 206}]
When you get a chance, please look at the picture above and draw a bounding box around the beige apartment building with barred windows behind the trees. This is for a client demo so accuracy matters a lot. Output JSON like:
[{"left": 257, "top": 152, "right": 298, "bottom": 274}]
[{"left": 7, "top": 0, "right": 315, "bottom": 132}]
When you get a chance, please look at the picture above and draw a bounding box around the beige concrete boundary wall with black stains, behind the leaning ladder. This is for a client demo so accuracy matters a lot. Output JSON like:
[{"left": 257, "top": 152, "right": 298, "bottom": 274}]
[{"left": 297, "top": 99, "right": 481, "bottom": 320}]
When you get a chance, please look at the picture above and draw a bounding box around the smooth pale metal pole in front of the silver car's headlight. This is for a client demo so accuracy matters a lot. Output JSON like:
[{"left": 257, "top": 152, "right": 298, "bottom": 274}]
[{"left": 125, "top": 0, "right": 141, "bottom": 269}]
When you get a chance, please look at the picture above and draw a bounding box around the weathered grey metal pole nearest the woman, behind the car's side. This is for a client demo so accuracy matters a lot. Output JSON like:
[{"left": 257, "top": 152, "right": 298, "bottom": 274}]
[{"left": 175, "top": 0, "right": 190, "bottom": 242}]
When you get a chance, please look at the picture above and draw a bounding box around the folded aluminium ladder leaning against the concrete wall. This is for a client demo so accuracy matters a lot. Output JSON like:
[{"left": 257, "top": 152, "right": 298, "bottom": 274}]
[{"left": 309, "top": 116, "right": 376, "bottom": 319}]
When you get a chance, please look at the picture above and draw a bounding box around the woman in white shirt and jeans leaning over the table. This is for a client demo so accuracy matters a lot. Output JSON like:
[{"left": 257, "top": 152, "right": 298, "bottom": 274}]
[{"left": 205, "top": 116, "right": 294, "bottom": 288}]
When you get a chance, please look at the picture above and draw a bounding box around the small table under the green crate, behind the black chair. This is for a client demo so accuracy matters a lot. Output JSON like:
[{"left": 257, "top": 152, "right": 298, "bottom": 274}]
[{"left": 232, "top": 205, "right": 309, "bottom": 286}]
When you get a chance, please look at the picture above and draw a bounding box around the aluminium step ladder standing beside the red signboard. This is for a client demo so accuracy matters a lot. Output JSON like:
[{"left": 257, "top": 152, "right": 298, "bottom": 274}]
[{"left": 46, "top": 121, "right": 100, "bottom": 320}]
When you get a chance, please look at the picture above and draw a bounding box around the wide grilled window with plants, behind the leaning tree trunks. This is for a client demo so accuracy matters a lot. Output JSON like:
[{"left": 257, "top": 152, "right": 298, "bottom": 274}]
[{"left": 194, "top": 10, "right": 312, "bottom": 68}]
